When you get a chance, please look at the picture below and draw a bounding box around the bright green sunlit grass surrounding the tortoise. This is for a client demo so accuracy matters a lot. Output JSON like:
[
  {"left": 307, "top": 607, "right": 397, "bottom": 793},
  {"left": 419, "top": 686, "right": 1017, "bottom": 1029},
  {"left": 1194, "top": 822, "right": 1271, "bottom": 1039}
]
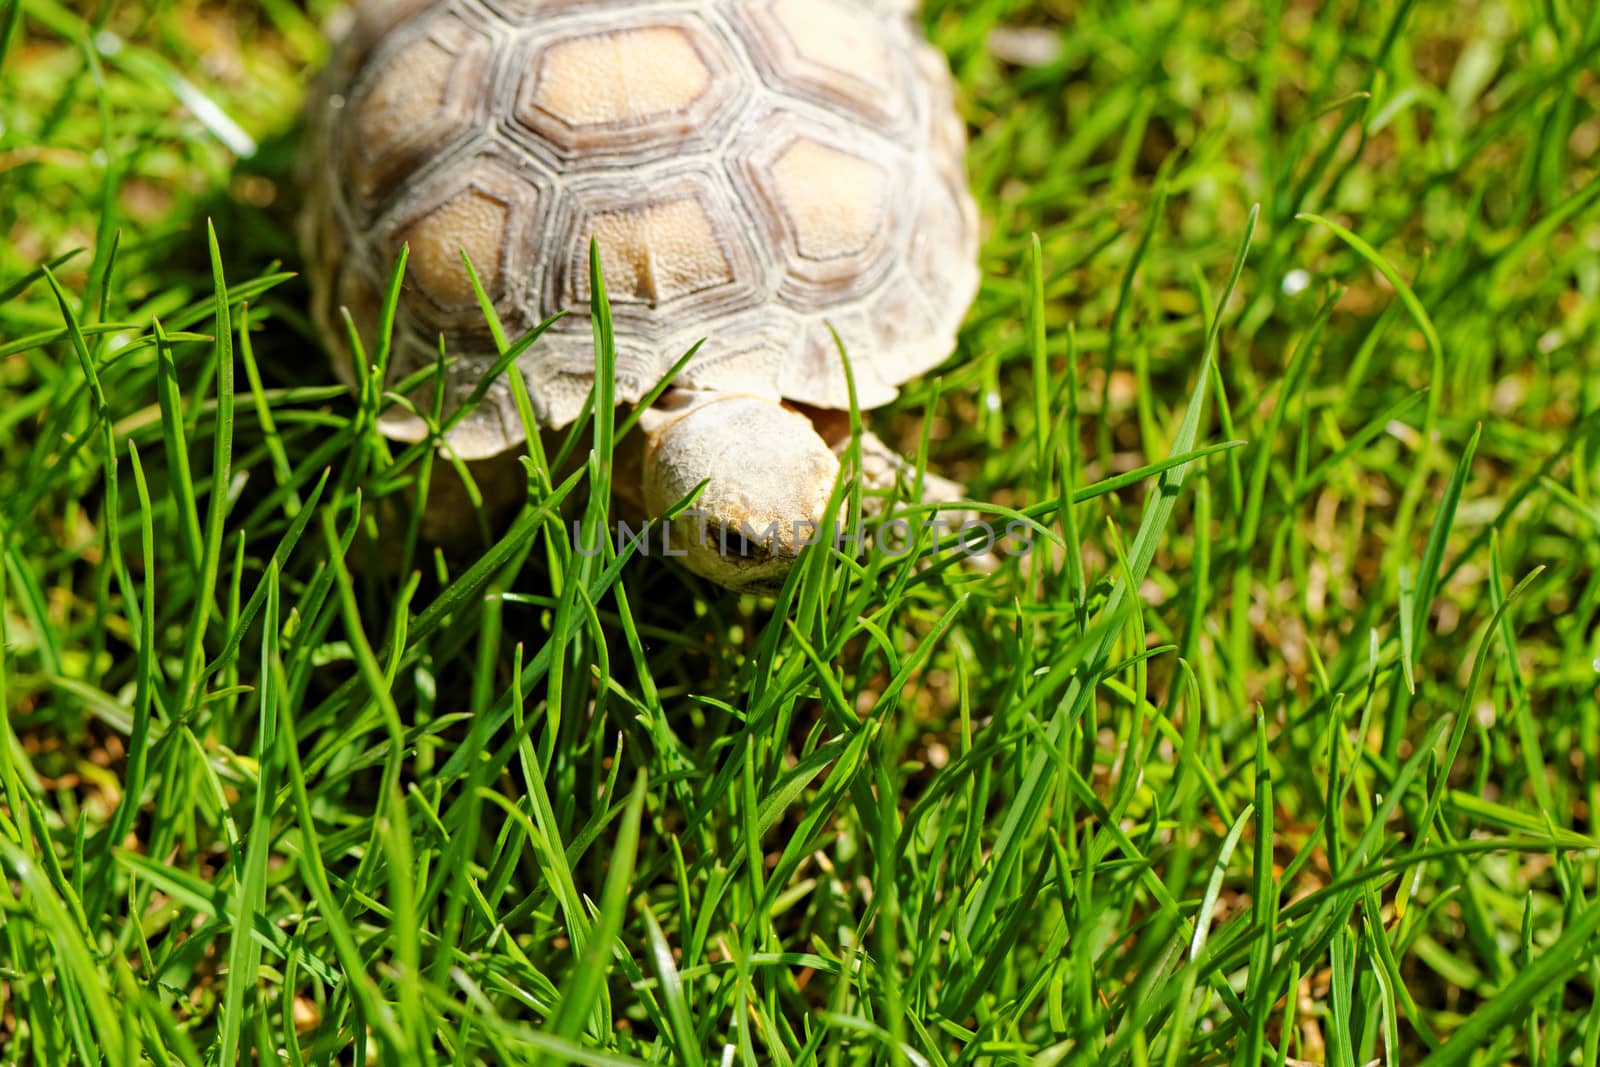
[{"left": 0, "top": 0, "right": 1600, "bottom": 1067}]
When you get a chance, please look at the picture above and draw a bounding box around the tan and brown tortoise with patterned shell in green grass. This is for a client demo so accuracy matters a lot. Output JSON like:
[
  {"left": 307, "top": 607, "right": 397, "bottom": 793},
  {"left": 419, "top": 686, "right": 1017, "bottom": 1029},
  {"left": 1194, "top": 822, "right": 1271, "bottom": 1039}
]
[{"left": 301, "top": 0, "right": 978, "bottom": 589}]
